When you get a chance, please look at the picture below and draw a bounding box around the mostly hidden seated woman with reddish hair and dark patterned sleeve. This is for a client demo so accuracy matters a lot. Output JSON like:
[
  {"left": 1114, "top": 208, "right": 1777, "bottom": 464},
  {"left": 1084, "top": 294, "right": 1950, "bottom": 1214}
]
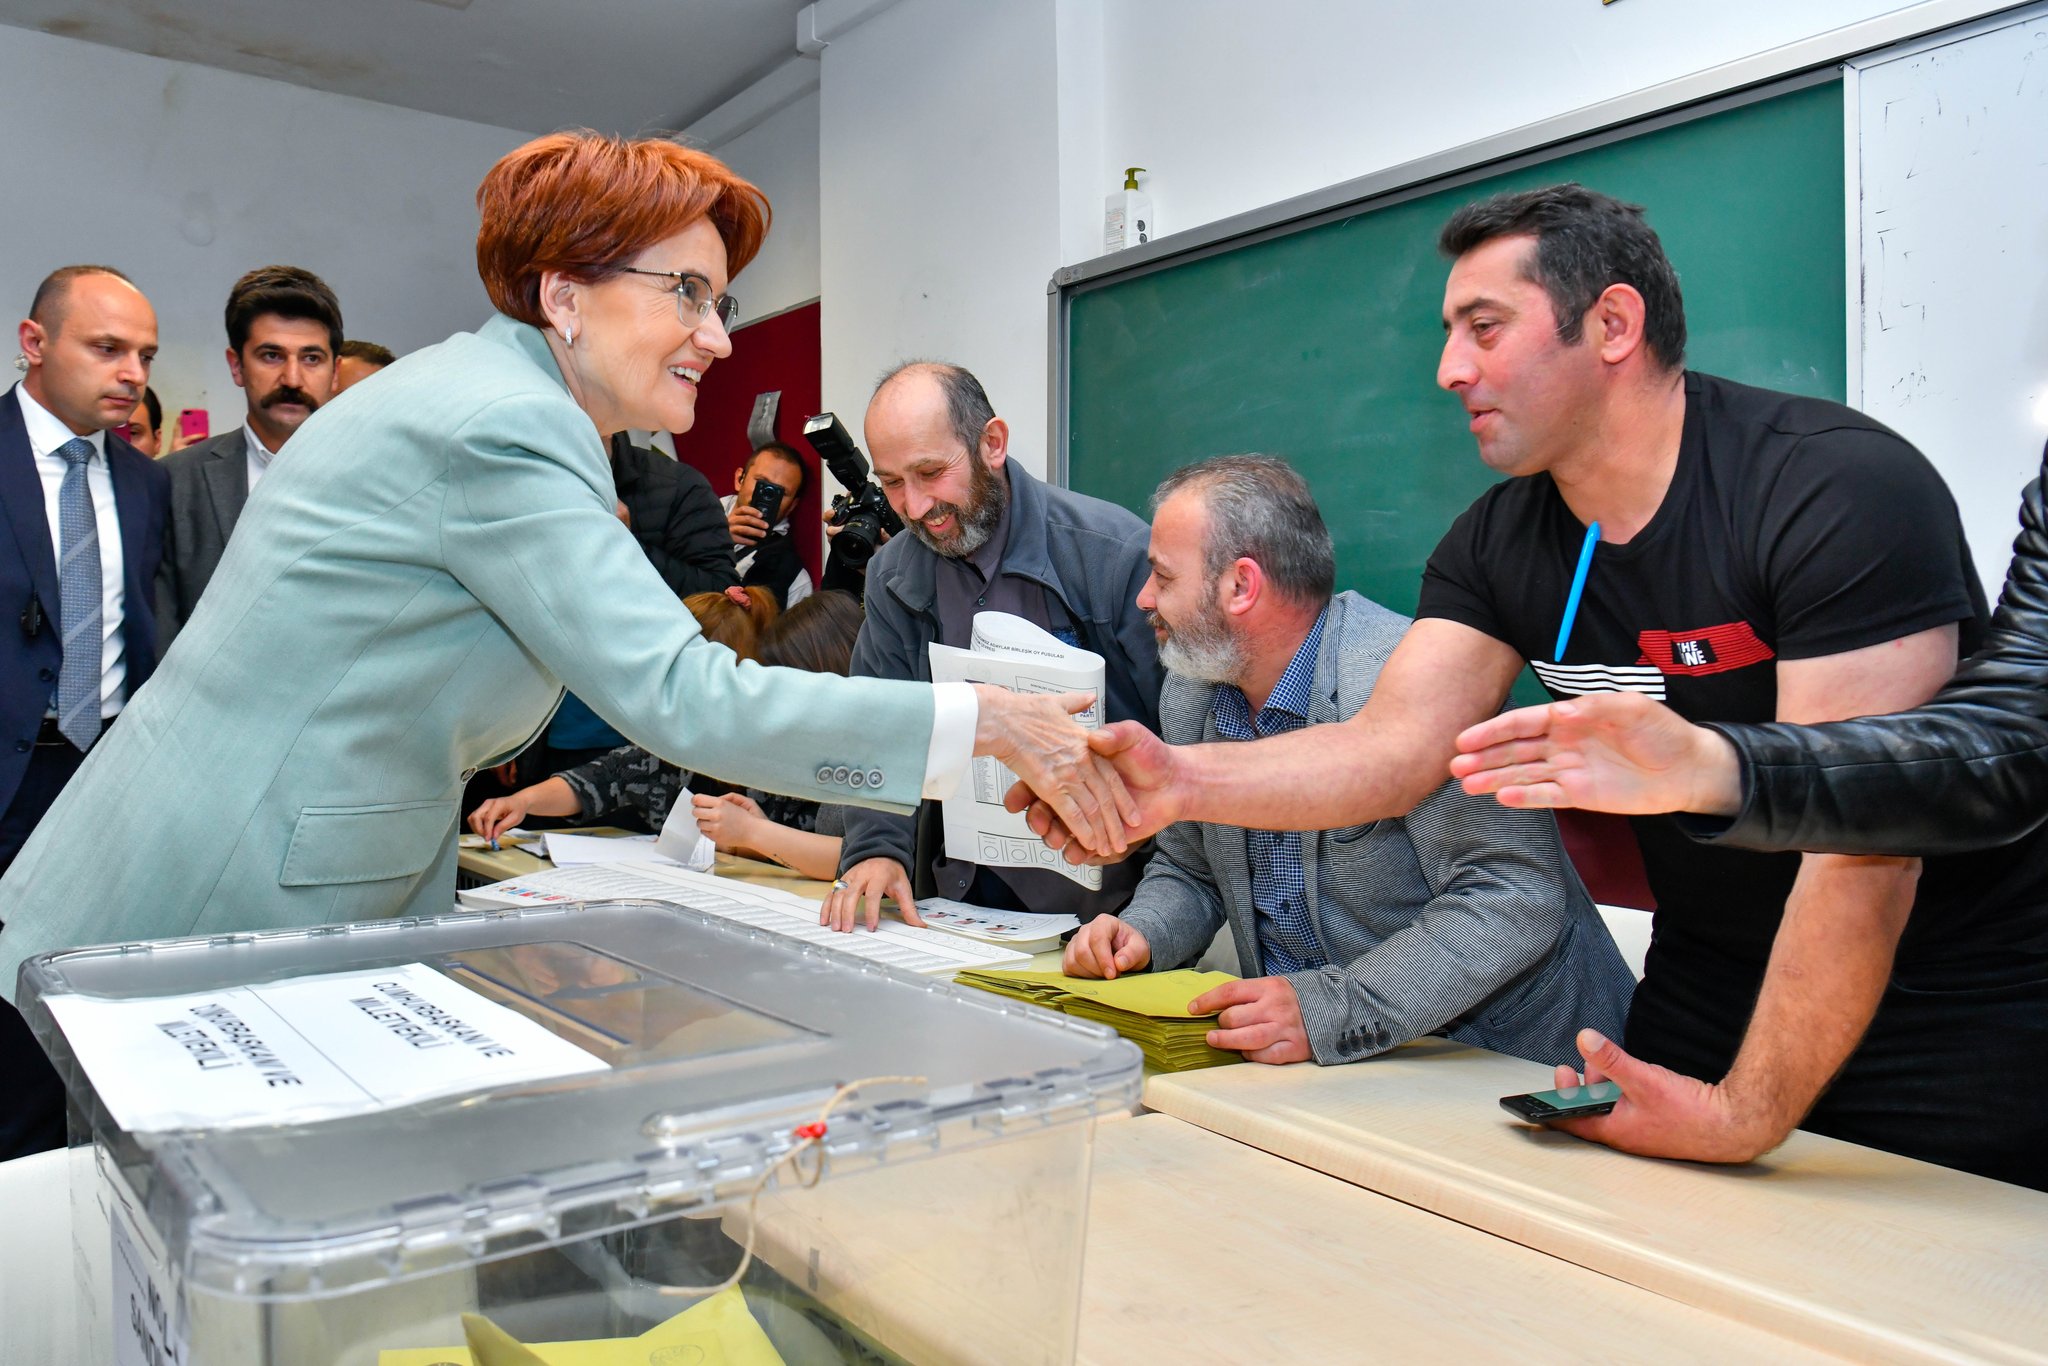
[{"left": 469, "top": 588, "right": 776, "bottom": 840}]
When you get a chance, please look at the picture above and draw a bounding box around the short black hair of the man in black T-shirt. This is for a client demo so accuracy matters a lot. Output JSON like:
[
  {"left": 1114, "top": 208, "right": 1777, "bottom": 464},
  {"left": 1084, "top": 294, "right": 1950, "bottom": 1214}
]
[{"left": 1436, "top": 184, "right": 1686, "bottom": 371}]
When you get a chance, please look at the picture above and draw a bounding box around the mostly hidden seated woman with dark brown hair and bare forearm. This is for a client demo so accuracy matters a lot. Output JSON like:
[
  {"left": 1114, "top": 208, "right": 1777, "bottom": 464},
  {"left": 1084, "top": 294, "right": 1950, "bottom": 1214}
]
[{"left": 690, "top": 592, "right": 860, "bottom": 881}]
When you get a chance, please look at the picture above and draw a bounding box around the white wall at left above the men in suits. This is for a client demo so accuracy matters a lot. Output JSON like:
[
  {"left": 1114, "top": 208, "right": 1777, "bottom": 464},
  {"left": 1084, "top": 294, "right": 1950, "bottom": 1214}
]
[{"left": 0, "top": 29, "right": 528, "bottom": 432}]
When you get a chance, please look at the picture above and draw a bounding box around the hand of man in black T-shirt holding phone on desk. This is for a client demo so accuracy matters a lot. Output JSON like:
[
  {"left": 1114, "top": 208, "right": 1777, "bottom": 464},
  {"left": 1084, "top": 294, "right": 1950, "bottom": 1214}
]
[{"left": 1550, "top": 1030, "right": 1798, "bottom": 1161}]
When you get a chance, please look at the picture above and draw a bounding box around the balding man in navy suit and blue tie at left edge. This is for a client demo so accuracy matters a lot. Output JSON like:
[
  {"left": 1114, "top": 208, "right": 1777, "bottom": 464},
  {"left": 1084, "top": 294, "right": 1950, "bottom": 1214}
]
[{"left": 0, "top": 266, "right": 170, "bottom": 1161}]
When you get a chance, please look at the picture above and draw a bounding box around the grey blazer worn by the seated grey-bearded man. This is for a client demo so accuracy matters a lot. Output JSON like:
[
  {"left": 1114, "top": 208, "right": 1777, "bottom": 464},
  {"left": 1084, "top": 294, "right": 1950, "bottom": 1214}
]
[{"left": 1122, "top": 592, "right": 1636, "bottom": 1063}]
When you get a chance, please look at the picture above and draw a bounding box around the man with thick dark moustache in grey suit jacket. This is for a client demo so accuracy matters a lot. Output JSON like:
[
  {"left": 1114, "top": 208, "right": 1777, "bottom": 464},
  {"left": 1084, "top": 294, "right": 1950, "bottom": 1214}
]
[{"left": 158, "top": 266, "right": 342, "bottom": 649}]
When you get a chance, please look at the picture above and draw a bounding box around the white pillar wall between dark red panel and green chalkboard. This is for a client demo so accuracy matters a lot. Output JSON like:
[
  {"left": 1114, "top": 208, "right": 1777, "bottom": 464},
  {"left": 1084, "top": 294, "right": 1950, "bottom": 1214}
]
[{"left": 819, "top": 0, "right": 1061, "bottom": 469}]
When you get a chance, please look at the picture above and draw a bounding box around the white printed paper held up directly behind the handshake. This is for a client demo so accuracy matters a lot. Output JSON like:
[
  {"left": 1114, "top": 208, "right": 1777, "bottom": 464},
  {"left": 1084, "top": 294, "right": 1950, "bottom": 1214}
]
[{"left": 932, "top": 612, "right": 1104, "bottom": 891}]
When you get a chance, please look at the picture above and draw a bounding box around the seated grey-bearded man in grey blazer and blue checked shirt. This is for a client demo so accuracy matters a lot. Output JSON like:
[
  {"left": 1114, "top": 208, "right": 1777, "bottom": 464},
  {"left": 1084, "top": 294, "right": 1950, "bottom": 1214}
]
[{"left": 1067, "top": 455, "right": 1634, "bottom": 1063}]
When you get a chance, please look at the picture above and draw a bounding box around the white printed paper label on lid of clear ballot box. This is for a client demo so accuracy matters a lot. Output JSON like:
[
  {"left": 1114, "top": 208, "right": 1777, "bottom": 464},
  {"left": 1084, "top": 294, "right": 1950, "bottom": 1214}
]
[{"left": 45, "top": 963, "right": 604, "bottom": 1133}]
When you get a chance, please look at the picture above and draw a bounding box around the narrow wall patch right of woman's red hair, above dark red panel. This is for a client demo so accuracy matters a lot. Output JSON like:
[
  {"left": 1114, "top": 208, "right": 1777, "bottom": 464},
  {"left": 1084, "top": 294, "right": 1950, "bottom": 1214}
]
[{"left": 686, "top": 90, "right": 819, "bottom": 322}]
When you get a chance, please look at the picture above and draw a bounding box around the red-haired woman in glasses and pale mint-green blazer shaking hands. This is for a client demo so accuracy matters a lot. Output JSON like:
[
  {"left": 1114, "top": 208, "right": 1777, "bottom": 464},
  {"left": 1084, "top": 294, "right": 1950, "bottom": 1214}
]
[{"left": 0, "top": 133, "right": 1122, "bottom": 1141}]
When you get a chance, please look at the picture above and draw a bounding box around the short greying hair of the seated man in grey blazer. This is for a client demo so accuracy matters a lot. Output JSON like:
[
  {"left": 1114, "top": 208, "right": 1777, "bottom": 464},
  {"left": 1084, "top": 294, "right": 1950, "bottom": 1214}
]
[{"left": 1151, "top": 455, "right": 1337, "bottom": 606}]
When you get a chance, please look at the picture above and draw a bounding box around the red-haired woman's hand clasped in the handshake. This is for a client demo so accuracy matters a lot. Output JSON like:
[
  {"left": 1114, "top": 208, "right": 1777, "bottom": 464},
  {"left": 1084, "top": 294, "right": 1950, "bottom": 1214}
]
[{"left": 975, "top": 684, "right": 1143, "bottom": 862}]
